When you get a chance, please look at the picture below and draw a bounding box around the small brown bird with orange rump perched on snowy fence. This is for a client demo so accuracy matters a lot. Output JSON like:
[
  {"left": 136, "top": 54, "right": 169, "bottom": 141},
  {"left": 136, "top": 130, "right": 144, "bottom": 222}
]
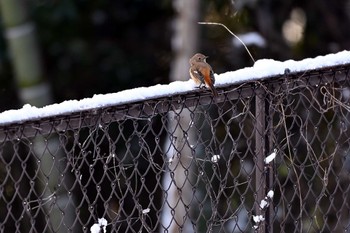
[{"left": 190, "top": 53, "right": 218, "bottom": 96}]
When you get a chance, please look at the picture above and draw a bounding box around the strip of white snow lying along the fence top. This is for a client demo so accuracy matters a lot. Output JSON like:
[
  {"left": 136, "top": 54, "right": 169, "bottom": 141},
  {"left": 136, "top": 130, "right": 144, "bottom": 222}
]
[{"left": 0, "top": 51, "right": 350, "bottom": 125}]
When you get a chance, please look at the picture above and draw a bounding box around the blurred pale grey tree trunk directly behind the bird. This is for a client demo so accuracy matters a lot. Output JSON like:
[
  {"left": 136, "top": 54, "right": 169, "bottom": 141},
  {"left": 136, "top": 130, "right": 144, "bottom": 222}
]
[{"left": 163, "top": 0, "right": 199, "bottom": 233}]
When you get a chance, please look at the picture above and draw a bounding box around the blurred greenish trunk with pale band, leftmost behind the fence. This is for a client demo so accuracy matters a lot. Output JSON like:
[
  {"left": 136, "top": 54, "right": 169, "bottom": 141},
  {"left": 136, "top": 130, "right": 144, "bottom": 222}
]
[{"left": 0, "top": 0, "right": 75, "bottom": 233}]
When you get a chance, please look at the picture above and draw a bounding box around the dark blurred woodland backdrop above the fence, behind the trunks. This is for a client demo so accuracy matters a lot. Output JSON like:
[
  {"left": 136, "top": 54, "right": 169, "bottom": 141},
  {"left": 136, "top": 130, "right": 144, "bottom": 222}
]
[{"left": 0, "top": 0, "right": 350, "bottom": 110}]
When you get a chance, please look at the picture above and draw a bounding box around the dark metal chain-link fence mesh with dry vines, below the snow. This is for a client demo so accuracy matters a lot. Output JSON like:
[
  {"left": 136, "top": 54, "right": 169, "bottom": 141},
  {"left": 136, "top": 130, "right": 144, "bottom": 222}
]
[{"left": 0, "top": 65, "right": 350, "bottom": 232}]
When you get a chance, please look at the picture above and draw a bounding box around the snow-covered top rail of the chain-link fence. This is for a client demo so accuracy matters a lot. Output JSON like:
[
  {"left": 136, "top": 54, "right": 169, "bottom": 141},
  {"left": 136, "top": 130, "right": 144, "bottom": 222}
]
[{"left": 0, "top": 51, "right": 350, "bottom": 141}]
